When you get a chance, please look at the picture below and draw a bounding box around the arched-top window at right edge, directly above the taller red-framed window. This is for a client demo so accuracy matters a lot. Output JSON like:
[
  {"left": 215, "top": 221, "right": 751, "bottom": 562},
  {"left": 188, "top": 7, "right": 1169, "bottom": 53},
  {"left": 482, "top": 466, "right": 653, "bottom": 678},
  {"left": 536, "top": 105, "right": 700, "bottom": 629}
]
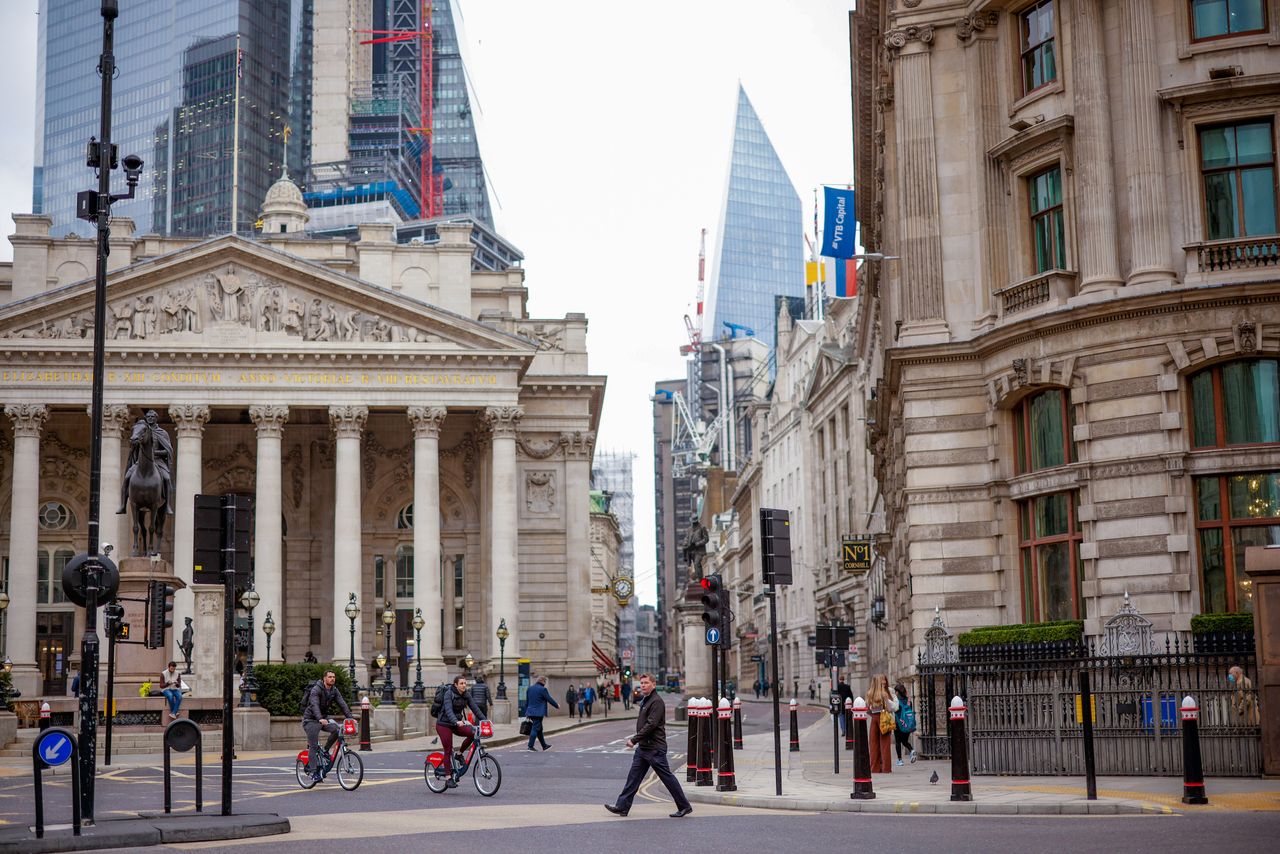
[{"left": 1188, "top": 359, "right": 1280, "bottom": 449}]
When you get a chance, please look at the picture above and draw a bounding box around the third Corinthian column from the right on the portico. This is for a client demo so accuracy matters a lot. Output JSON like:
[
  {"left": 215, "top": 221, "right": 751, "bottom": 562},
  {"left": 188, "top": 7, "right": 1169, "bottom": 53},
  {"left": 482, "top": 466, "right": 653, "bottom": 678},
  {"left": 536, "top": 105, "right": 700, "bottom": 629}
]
[{"left": 327, "top": 406, "right": 368, "bottom": 673}]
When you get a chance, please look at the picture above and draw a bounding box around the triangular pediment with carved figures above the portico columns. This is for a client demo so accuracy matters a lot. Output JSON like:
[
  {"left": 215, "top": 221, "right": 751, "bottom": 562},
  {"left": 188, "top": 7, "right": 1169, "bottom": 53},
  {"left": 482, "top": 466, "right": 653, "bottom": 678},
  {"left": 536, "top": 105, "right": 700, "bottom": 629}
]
[{"left": 0, "top": 236, "right": 534, "bottom": 357}]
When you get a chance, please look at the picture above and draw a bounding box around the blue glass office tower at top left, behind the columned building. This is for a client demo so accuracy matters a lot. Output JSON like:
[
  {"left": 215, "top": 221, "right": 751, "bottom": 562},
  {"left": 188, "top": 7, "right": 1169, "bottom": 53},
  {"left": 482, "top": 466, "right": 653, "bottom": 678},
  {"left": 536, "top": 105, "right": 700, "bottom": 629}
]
[{"left": 32, "top": 0, "right": 315, "bottom": 236}]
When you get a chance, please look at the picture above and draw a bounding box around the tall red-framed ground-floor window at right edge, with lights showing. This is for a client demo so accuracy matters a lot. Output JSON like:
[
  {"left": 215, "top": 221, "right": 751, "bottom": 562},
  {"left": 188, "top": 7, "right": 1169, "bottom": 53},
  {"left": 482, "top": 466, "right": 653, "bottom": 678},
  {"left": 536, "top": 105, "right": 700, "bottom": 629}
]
[{"left": 1194, "top": 471, "right": 1280, "bottom": 613}]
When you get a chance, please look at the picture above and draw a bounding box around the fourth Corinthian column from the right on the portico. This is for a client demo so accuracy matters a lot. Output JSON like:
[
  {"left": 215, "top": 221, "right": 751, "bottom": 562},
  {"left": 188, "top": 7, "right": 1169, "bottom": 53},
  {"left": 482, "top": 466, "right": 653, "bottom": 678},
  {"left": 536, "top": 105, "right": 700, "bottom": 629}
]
[{"left": 248, "top": 406, "right": 289, "bottom": 661}]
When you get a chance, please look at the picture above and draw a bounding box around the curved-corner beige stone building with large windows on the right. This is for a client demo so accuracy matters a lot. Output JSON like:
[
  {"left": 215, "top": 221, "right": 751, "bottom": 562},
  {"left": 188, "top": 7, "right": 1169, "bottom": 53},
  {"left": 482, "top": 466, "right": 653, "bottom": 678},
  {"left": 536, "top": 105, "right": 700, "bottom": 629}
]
[{"left": 850, "top": 0, "right": 1280, "bottom": 671}]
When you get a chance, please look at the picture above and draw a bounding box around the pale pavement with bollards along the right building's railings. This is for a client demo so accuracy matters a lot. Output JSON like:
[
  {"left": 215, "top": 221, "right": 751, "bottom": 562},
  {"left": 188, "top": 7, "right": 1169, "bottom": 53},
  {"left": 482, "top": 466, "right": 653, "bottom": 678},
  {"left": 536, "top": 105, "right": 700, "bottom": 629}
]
[{"left": 677, "top": 702, "right": 1280, "bottom": 816}]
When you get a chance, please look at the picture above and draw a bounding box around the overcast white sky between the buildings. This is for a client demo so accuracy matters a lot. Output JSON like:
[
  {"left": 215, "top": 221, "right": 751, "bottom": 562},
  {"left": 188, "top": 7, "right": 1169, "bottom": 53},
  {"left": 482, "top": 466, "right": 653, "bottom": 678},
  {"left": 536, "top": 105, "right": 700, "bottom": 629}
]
[{"left": 0, "top": 0, "right": 854, "bottom": 604}]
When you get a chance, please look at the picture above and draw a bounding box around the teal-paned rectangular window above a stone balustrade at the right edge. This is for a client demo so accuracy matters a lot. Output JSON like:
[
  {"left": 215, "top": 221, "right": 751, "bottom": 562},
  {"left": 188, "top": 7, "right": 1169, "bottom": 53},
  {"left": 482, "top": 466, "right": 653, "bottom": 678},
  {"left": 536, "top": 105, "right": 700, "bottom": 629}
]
[{"left": 1199, "top": 119, "right": 1276, "bottom": 241}]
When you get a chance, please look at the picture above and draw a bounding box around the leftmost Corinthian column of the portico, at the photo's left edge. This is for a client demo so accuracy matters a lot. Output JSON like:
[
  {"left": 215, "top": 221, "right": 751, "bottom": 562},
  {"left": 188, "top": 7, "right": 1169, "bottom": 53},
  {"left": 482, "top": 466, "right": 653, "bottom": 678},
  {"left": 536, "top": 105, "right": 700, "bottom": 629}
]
[{"left": 4, "top": 403, "right": 49, "bottom": 697}]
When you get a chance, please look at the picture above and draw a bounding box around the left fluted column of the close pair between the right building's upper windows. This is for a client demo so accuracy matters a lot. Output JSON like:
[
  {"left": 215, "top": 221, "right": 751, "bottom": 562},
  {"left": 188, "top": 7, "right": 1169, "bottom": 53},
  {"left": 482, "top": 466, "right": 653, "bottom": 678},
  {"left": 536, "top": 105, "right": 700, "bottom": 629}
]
[{"left": 1064, "top": 0, "right": 1121, "bottom": 294}]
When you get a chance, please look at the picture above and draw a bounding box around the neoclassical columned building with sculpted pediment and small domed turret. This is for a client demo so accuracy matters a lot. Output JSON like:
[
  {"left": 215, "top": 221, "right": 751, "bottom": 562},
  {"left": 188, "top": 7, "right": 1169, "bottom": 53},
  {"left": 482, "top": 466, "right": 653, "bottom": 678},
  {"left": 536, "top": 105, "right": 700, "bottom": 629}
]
[{"left": 0, "top": 181, "right": 604, "bottom": 698}]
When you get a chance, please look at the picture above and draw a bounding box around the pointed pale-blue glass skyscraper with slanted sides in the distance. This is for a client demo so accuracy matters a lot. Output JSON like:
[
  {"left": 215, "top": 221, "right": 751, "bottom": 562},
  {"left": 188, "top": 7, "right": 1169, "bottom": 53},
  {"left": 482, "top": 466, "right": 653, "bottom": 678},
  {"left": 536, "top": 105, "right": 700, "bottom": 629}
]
[{"left": 703, "top": 86, "right": 804, "bottom": 347}]
